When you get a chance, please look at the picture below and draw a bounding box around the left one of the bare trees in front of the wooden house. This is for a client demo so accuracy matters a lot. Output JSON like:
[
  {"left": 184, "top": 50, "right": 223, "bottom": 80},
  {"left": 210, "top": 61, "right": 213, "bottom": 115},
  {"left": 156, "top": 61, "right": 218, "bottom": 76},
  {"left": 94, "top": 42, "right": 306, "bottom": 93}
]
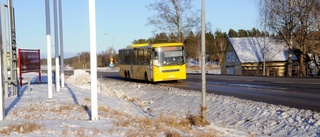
[{"left": 261, "top": 0, "right": 300, "bottom": 77}]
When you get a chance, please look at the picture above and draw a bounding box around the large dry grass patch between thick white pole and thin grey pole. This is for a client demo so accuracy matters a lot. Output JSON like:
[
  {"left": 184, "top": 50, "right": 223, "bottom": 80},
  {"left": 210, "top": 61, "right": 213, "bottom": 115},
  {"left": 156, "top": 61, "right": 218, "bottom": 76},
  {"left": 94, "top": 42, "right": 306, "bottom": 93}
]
[{"left": 99, "top": 106, "right": 216, "bottom": 137}]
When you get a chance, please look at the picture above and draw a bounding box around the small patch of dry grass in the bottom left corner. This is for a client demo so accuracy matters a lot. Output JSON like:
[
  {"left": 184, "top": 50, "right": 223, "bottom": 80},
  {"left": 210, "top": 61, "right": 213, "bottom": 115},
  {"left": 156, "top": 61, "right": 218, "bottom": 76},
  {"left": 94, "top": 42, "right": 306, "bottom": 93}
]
[{"left": 0, "top": 122, "right": 44, "bottom": 135}]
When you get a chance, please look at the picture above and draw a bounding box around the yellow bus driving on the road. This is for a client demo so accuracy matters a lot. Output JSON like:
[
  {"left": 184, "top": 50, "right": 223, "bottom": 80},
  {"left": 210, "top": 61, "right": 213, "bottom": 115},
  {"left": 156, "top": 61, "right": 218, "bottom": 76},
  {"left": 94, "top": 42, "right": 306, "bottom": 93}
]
[{"left": 119, "top": 43, "right": 187, "bottom": 82}]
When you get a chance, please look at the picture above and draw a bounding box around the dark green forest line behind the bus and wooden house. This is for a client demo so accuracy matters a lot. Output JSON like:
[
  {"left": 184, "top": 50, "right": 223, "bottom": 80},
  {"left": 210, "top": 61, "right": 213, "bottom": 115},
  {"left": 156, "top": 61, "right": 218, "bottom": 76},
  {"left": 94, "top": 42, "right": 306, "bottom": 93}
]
[{"left": 132, "top": 28, "right": 269, "bottom": 64}]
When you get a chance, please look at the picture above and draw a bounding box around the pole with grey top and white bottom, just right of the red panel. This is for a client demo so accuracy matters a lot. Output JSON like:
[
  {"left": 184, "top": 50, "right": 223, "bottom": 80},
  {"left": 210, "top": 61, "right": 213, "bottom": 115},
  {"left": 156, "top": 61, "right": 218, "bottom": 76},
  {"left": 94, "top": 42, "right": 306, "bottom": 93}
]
[{"left": 45, "top": 0, "right": 52, "bottom": 99}]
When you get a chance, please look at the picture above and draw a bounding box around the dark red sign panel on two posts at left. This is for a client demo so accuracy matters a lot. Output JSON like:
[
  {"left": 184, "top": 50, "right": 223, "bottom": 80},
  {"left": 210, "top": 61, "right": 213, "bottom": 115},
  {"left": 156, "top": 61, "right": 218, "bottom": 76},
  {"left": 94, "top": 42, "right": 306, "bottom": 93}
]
[{"left": 18, "top": 49, "right": 41, "bottom": 85}]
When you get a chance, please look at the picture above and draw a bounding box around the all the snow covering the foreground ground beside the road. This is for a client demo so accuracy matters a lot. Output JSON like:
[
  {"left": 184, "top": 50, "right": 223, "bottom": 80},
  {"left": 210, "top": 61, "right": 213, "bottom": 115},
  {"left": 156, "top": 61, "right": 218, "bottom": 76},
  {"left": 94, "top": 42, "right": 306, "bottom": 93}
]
[{"left": 0, "top": 70, "right": 320, "bottom": 137}]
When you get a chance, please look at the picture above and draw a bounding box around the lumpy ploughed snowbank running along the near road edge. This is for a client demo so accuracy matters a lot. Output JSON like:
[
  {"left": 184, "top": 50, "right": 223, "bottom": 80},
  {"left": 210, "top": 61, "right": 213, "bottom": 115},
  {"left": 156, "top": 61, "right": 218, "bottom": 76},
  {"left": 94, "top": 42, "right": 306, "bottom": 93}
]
[{"left": 65, "top": 70, "right": 320, "bottom": 136}]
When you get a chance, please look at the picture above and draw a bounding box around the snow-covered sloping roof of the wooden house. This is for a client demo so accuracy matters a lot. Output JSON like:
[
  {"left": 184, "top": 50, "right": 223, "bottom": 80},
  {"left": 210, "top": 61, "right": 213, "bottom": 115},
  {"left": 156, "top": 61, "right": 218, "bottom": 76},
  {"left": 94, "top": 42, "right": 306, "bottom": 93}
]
[{"left": 229, "top": 37, "right": 298, "bottom": 63}]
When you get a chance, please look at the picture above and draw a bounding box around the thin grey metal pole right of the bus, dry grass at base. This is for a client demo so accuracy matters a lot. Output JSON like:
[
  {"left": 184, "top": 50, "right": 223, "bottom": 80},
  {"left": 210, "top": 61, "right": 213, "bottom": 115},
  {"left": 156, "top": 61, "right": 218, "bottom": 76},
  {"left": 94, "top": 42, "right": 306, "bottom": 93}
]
[{"left": 201, "top": 0, "right": 207, "bottom": 121}]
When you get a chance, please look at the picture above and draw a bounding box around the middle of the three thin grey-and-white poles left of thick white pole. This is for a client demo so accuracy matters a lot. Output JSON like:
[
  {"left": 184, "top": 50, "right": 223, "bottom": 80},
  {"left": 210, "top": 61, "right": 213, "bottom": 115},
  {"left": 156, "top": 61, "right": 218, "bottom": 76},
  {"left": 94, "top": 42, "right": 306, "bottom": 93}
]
[{"left": 53, "top": 0, "right": 60, "bottom": 92}]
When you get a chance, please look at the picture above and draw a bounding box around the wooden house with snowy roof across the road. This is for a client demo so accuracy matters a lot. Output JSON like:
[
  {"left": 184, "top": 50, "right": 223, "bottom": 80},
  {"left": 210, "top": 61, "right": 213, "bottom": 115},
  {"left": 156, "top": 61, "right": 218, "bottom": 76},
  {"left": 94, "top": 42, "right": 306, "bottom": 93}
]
[{"left": 221, "top": 37, "right": 299, "bottom": 76}]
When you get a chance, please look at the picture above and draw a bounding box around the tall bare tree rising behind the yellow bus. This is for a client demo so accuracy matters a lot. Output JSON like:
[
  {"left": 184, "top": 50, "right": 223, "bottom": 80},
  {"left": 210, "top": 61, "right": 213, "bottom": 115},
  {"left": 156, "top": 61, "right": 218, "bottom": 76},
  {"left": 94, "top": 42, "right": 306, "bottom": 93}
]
[{"left": 147, "top": 0, "right": 200, "bottom": 42}]
